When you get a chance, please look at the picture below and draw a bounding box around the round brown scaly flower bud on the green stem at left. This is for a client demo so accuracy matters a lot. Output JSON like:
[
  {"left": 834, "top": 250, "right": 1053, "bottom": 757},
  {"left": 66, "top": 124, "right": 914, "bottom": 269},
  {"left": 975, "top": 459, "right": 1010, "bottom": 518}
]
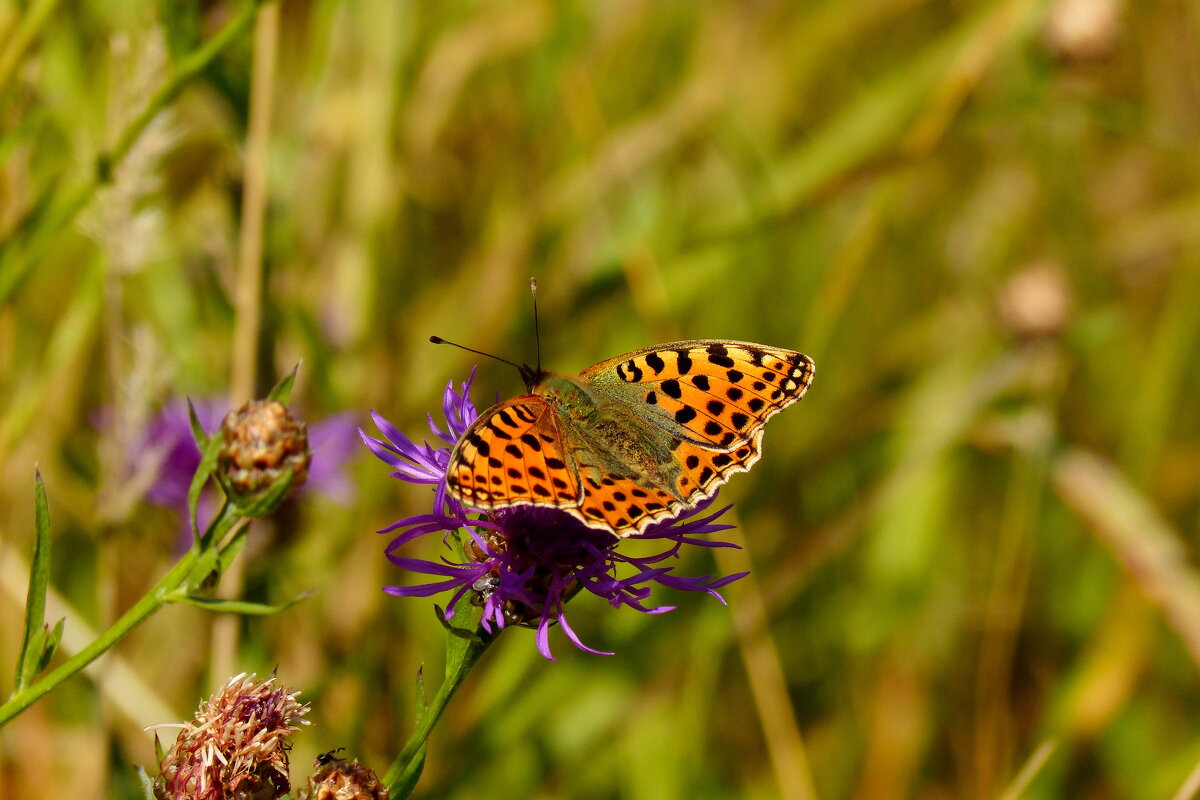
[{"left": 217, "top": 401, "right": 312, "bottom": 497}]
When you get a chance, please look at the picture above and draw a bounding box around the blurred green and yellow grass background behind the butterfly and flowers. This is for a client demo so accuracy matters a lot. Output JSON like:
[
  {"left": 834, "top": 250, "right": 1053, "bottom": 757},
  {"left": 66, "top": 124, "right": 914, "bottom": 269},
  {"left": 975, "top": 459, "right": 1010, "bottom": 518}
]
[{"left": 0, "top": 0, "right": 1200, "bottom": 800}]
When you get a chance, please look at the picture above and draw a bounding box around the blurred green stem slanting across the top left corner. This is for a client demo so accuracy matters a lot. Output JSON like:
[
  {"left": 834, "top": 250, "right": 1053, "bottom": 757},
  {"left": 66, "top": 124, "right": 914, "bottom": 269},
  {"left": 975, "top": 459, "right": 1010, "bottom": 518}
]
[{"left": 0, "top": 0, "right": 268, "bottom": 303}]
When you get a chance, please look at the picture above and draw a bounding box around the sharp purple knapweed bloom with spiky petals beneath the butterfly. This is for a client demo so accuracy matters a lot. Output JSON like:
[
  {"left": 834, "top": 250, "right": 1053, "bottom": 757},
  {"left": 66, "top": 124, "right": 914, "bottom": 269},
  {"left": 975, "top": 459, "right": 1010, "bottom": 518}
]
[{"left": 359, "top": 371, "right": 745, "bottom": 660}]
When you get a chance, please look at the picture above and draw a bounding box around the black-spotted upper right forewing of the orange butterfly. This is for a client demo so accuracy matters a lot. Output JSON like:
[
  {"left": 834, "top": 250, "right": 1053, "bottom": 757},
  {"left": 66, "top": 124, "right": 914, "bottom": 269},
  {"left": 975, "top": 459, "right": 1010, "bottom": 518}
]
[{"left": 580, "top": 339, "right": 812, "bottom": 452}]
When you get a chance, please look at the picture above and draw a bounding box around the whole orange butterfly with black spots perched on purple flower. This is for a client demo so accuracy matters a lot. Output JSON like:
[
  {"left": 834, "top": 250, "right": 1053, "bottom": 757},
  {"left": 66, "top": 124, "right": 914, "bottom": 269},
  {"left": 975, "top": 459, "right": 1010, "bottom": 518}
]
[{"left": 446, "top": 339, "right": 814, "bottom": 537}]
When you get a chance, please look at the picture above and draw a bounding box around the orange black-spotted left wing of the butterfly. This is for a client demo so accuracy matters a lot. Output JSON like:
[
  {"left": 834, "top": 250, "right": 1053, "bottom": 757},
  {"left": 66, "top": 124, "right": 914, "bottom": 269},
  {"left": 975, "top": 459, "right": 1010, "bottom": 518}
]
[{"left": 446, "top": 395, "right": 580, "bottom": 509}]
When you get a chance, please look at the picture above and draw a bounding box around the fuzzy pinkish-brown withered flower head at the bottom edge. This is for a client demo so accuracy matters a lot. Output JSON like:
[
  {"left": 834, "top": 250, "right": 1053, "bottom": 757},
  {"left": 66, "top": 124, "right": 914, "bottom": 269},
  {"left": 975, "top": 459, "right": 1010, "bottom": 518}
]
[{"left": 152, "top": 673, "right": 308, "bottom": 800}]
